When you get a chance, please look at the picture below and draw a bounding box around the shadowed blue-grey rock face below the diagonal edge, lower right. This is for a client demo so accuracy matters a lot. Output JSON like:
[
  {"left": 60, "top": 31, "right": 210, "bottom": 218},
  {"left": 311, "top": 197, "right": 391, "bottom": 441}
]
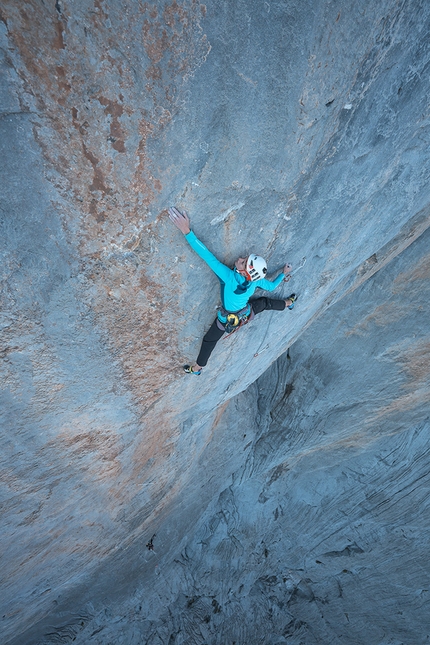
[{"left": 11, "top": 223, "right": 430, "bottom": 645}]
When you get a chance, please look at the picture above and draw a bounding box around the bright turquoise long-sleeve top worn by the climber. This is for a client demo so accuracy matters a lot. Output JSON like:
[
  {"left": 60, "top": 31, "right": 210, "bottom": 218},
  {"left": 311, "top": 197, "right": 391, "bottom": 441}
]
[{"left": 185, "top": 231, "right": 284, "bottom": 311}]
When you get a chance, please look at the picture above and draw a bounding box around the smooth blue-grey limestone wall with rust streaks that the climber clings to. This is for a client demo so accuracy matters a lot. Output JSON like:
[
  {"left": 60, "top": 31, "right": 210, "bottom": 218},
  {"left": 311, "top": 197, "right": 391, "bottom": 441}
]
[{"left": 0, "top": 0, "right": 430, "bottom": 643}]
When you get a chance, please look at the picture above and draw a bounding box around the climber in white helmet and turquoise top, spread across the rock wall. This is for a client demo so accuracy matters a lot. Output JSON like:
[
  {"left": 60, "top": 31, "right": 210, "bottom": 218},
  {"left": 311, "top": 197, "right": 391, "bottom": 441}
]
[{"left": 168, "top": 208, "right": 297, "bottom": 376}]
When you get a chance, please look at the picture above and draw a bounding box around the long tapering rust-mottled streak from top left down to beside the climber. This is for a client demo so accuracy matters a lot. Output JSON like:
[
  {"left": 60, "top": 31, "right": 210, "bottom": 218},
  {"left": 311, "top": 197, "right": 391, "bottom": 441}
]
[{"left": 3, "top": 0, "right": 207, "bottom": 422}]
